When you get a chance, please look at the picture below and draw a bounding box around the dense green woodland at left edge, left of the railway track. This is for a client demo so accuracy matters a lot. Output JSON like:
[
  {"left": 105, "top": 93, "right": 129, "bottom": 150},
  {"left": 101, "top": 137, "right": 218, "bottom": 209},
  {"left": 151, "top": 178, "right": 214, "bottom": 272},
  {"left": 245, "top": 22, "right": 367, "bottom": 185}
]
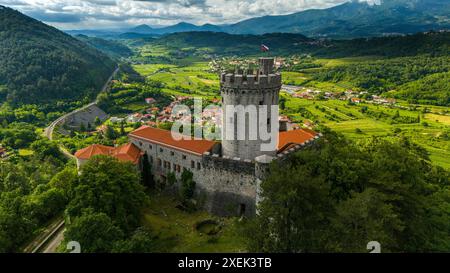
[{"left": 0, "top": 136, "right": 68, "bottom": 252}]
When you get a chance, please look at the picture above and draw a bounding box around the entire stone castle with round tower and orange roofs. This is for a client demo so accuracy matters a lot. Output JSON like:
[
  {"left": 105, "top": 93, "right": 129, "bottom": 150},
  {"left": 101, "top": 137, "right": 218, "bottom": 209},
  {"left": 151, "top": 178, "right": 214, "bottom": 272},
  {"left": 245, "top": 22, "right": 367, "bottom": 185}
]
[{"left": 75, "top": 58, "right": 320, "bottom": 217}]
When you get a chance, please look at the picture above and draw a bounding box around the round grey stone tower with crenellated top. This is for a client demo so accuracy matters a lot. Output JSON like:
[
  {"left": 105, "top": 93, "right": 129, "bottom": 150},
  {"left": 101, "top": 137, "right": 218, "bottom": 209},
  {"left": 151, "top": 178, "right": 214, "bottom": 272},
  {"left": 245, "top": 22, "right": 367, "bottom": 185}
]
[{"left": 220, "top": 58, "right": 281, "bottom": 161}]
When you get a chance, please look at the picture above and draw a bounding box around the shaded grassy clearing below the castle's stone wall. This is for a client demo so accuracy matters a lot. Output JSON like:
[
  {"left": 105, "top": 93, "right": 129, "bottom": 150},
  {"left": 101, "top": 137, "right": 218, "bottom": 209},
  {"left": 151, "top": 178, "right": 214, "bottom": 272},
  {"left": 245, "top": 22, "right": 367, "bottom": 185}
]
[{"left": 143, "top": 192, "right": 245, "bottom": 253}]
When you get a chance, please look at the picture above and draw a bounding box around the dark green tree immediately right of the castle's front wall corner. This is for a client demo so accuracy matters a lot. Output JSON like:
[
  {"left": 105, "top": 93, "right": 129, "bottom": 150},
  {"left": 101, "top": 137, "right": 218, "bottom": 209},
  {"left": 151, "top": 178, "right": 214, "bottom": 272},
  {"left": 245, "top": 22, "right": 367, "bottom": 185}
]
[{"left": 245, "top": 158, "right": 333, "bottom": 252}]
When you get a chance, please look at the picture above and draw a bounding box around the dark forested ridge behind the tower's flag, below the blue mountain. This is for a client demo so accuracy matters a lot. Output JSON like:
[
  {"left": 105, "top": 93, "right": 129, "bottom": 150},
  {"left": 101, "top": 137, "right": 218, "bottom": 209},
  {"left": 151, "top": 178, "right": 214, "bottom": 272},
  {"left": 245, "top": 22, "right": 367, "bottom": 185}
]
[{"left": 148, "top": 32, "right": 450, "bottom": 58}]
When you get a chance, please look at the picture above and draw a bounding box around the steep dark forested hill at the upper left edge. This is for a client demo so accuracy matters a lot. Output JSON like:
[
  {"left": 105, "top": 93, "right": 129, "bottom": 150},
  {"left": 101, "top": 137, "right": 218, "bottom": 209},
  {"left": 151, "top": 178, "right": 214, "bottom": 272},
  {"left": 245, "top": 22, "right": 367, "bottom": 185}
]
[{"left": 0, "top": 6, "right": 116, "bottom": 104}]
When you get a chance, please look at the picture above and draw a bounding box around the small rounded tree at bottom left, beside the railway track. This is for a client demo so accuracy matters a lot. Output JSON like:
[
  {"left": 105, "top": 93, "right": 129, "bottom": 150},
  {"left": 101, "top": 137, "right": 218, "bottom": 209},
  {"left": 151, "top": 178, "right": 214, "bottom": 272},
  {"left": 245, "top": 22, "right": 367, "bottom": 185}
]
[{"left": 64, "top": 209, "right": 124, "bottom": 253}]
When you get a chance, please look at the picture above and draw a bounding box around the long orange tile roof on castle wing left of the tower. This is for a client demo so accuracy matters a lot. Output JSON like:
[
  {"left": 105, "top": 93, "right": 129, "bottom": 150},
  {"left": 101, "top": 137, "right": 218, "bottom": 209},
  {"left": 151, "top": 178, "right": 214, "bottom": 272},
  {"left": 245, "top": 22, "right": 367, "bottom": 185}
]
[{"left": 130, "top": 126, "right": 216, "bottom": 155}]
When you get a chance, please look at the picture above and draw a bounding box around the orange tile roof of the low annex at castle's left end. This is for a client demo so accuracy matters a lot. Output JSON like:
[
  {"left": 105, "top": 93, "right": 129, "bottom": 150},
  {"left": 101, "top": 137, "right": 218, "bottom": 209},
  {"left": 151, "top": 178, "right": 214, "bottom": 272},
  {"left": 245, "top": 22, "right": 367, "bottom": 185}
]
[{"left": 75, "top": 143, "right": 142, "bottom": 164}]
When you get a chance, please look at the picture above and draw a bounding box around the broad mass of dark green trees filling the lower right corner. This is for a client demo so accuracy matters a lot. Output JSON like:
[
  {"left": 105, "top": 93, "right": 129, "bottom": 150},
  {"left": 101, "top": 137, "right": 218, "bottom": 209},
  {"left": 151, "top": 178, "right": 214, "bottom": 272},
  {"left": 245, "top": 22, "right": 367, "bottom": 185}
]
[{"left": 245, "top": 132, "right": 450, "bottom": 252}]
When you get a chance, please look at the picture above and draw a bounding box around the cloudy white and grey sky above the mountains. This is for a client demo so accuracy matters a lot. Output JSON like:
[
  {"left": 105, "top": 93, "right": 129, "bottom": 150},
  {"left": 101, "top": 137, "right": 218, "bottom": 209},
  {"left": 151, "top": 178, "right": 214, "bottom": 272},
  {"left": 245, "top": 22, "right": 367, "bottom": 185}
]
[{"left": 0, "top": 0, "right": 380, "bottom": 29}]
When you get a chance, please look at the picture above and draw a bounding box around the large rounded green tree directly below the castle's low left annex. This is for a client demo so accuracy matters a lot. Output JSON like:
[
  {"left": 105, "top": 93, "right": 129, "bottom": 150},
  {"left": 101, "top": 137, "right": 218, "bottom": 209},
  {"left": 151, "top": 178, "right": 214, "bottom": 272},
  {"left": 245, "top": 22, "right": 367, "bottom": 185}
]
[{"left": 67, "top": 156, "right": 146, "bottom": 232}]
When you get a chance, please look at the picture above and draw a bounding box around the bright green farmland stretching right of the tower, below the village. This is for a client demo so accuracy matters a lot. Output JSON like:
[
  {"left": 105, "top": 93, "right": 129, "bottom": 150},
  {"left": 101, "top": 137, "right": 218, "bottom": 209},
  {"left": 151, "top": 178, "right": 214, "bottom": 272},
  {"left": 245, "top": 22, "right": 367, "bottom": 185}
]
[{"left": 283, "top": 95, "right": 450, "bottom": 169}]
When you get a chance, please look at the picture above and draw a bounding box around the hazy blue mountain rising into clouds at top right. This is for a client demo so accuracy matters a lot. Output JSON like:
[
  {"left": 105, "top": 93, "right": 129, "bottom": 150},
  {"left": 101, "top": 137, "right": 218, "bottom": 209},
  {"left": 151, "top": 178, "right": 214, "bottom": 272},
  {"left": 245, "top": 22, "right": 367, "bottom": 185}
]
[{"left": 225, "top": 0, "right": 450, "bottom": 38}]
